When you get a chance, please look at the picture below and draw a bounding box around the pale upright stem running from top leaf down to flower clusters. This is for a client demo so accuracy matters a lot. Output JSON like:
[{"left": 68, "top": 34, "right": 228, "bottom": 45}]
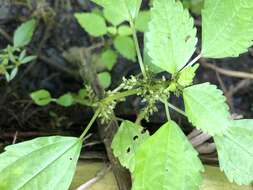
[{"left": 129, "top": 19, "right": 147, "bottom": 78}]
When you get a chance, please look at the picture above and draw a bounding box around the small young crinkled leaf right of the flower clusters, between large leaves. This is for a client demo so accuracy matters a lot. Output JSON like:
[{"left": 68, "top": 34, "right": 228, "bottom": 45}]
[{"left": 177, "top": 64, "right": 199, "bottom": 87}]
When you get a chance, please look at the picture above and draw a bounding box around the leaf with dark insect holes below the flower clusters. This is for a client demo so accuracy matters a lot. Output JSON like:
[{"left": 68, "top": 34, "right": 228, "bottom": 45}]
[{"left": 112, "top": 121, "right": 149, "bottom": 172}]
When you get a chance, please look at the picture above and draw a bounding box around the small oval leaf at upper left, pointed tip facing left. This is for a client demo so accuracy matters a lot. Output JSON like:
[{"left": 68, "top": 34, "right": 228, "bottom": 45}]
[{"left": 75, "top": 13, "right": 107, "bottom": 37}]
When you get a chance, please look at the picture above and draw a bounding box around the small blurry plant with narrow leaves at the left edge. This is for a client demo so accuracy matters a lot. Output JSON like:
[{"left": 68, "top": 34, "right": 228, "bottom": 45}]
[{"left": 0, "top": 19, "right": 36, "bottom": 82}]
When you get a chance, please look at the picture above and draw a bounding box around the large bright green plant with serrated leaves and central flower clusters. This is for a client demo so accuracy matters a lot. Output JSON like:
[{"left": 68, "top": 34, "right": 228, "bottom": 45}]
[{"left": 0, "top": 0, "right": 253, "bottom": 190}]
